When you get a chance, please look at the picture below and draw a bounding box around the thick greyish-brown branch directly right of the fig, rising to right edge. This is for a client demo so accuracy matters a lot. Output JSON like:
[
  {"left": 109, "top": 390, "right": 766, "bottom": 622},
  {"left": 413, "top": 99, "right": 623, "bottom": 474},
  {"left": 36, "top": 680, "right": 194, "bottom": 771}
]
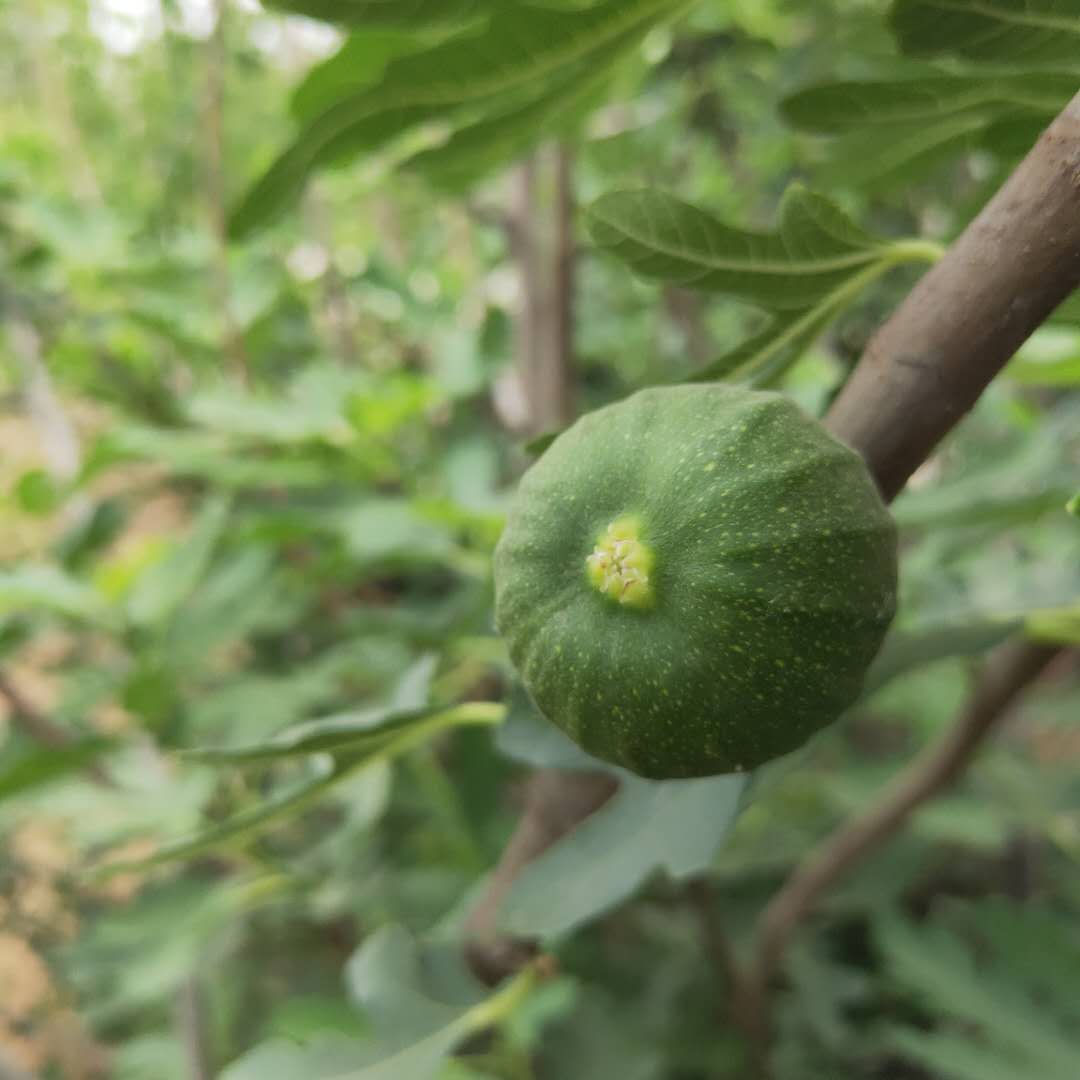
[{"left": 827, "top": 94, "right": 1080, "bottom": 499}]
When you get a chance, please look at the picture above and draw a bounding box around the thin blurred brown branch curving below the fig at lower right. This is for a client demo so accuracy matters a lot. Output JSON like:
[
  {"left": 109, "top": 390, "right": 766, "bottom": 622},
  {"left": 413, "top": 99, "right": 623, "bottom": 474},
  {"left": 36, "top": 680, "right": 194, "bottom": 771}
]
[{"left": 732, "top": 642, "right": 1061, "bottom": 1044}]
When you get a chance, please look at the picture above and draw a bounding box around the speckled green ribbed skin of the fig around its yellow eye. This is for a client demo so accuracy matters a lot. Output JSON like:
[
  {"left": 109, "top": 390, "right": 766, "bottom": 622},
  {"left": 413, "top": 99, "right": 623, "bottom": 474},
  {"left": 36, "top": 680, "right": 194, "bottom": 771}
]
[{"left": 495, "top": 383, "right": 896, "bottom": 779}]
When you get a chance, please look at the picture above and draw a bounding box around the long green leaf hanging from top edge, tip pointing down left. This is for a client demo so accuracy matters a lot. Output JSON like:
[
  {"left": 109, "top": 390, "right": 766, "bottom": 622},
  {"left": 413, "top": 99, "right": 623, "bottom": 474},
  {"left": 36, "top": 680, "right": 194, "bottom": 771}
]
[{"left": 231, "top": 0, "right": 688, "bottom": 235}]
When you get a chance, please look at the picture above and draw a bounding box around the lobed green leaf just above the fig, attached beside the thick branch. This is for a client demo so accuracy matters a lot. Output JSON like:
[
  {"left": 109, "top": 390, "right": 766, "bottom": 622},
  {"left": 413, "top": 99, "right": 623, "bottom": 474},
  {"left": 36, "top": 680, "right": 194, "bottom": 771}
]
[{"left": 589, "top": 186, "right": 887, "bottom": 310}]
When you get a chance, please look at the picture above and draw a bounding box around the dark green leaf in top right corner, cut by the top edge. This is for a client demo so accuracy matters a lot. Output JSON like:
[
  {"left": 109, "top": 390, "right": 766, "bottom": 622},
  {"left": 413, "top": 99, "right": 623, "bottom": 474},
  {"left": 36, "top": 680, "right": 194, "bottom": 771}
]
[{"left": 890, "top": 0, "right": 1080, "bottom": 67}]
